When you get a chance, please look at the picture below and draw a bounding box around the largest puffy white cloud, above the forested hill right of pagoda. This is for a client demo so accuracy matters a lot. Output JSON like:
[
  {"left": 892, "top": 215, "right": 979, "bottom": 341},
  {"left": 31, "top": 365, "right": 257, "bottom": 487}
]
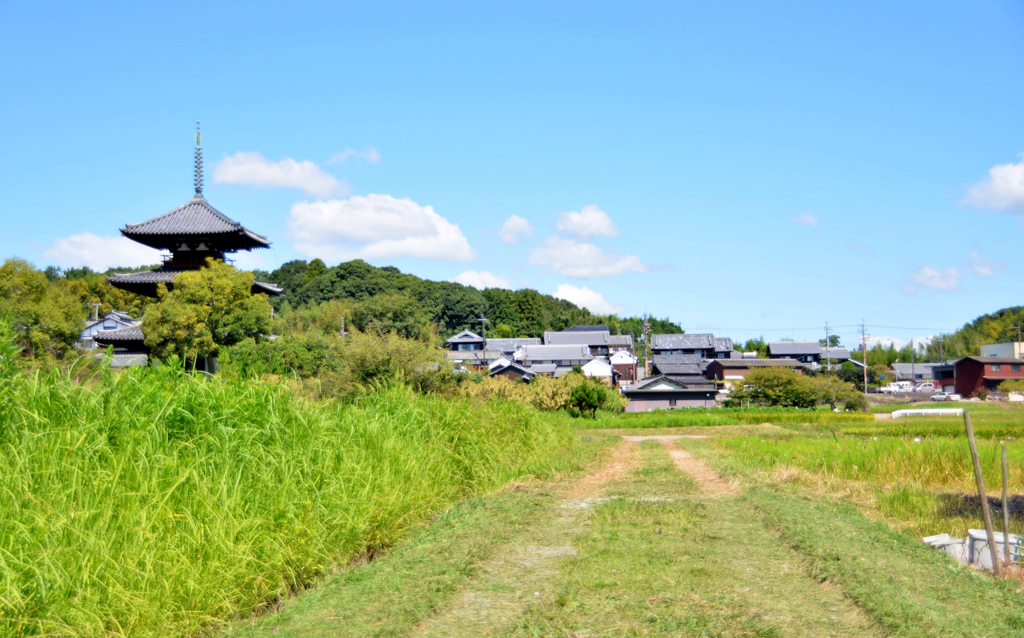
[{"left": 288, "top": 195, "right": 476, "bottom": 261}]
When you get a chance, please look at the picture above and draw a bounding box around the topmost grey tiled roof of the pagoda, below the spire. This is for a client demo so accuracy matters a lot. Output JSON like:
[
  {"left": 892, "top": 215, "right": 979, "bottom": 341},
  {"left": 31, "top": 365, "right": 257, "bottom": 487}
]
[{"left": 121, "top": 195, "right": 270, "bottom": 250}]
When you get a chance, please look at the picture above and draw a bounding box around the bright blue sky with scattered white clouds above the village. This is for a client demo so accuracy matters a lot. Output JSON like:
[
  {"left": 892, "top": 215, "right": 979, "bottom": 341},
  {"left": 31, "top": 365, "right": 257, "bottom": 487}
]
[{"left": 0, "top": 1, "right": 1024, "bottom": 350}]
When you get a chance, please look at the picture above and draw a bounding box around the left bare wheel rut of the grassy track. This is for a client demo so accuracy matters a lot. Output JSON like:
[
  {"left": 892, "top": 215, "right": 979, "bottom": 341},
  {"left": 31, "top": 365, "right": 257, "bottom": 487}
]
[{"left": 415, "top": 440, "right": 637, "bottom": 637}]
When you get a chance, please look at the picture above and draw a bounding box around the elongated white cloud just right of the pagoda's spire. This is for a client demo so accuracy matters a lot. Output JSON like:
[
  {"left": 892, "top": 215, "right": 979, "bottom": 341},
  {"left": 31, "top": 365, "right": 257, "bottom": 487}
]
[{"left": 213, "top": 152, "right": 351, "bottom": 198}]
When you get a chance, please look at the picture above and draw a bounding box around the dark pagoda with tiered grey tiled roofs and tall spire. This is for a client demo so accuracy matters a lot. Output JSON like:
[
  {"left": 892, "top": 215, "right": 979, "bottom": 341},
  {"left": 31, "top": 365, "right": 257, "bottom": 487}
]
[{"left": 95, "top": 124, "right": 282, "bottom": 352}]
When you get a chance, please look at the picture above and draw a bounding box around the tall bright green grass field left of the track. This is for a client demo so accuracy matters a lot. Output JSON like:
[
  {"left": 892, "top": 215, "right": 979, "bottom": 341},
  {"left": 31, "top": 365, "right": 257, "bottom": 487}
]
[{"left": 0, "top": 367, "right": 574, "bottom": 636}]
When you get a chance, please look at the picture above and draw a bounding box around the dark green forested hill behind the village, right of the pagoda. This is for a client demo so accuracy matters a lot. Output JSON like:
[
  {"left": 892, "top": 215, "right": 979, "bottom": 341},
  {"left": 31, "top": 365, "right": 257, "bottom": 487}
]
[{"left": 256, "top": 259, "right": 683, "bottom": 341}]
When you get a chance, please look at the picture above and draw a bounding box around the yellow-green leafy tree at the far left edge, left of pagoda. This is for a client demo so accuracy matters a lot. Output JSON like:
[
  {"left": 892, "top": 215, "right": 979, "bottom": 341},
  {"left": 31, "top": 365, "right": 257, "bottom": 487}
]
[{"left": 0, "top": 259, "right": 85, "bottom": 356}]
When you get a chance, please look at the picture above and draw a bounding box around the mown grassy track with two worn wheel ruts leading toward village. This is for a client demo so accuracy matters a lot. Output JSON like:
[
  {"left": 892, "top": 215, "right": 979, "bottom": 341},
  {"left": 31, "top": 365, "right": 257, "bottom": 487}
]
[{"left": 229, "top": 432, "right": 1024, "bottom": 638}]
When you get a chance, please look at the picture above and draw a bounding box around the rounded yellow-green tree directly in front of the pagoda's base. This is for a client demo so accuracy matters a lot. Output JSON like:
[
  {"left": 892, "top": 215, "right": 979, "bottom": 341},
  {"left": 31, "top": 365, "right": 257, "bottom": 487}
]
[{"left": 142, "top": 259, "right": 270, "bottom": 361}]
